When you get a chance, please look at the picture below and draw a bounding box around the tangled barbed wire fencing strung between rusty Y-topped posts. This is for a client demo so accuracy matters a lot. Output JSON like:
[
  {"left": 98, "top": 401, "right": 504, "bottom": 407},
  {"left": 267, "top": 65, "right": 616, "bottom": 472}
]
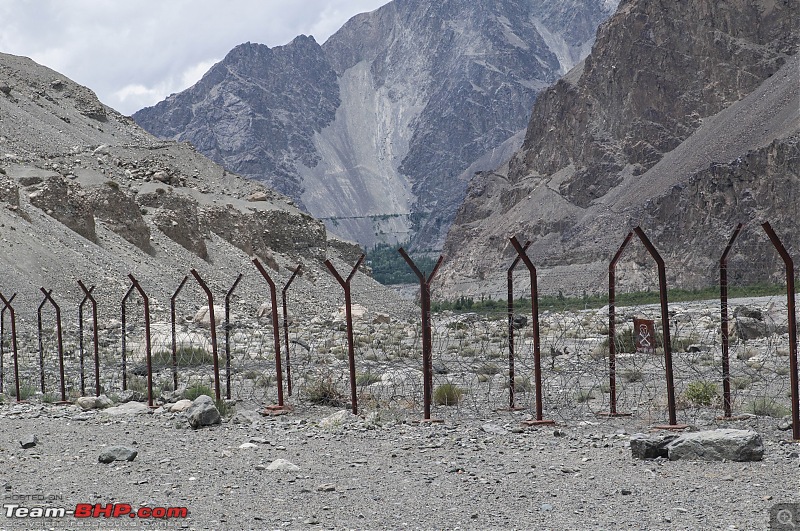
[{"left": 0, "top": 226, "right": 797, "bottom": 436}]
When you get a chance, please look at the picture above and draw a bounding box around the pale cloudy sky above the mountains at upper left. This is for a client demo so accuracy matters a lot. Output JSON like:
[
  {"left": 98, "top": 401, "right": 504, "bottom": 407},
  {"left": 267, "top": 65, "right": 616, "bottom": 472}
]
[{"left": 0, "top": 0, "right": 388, "bottom": 114}]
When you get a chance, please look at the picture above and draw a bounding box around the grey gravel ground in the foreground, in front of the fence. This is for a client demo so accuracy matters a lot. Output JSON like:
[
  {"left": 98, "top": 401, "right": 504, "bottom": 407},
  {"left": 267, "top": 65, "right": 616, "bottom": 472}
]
[{"left": 0, "top": 403, "right": 800, "bottom": 529}]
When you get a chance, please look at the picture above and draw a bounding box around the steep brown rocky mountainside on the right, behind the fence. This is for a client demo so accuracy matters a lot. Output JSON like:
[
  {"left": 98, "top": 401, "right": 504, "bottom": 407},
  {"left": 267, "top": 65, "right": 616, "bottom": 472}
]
[{"left": 442, "top": 0, "right": 800, "bottom": 300}]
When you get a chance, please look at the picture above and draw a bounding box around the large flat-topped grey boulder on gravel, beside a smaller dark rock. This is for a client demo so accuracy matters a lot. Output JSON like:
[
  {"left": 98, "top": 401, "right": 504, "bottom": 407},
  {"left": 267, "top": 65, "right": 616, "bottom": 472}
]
[{"left": 667, "top": 429, "right": 764, "bottom": 461}]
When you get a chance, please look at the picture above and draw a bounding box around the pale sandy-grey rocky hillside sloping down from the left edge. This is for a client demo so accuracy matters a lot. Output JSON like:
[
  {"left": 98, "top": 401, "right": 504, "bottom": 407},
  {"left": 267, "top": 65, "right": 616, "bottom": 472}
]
[{"left": 0, "top": 54, "right": 412, "bottom": 318}]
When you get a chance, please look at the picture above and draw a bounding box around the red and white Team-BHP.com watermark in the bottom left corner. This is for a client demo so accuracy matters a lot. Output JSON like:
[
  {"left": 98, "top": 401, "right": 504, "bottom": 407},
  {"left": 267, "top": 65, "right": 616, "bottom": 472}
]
[{"left": 3, "top": 494, "right": 189, "bottom": 522}]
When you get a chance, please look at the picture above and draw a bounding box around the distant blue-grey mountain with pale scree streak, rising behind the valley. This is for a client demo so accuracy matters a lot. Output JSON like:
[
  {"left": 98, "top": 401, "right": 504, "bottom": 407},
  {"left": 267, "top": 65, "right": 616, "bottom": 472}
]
[{"left": 134, "top": 0, "right": 617, "bottom": 249}]
